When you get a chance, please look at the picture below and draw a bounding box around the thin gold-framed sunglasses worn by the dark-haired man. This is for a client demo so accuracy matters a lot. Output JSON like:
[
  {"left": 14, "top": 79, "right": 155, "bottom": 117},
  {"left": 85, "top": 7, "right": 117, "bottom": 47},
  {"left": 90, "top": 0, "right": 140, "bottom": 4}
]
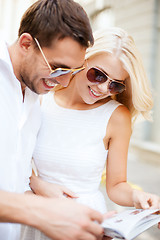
[{"left": 34, "top": 38, "right": 85, "bottom": 78}]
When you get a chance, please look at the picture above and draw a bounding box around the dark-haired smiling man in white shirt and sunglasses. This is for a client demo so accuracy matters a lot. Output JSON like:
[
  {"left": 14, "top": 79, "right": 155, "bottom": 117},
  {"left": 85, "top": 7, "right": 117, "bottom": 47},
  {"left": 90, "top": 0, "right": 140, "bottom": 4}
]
[{"left": 0, "top": 0, "right": 102, "bottom": 240}]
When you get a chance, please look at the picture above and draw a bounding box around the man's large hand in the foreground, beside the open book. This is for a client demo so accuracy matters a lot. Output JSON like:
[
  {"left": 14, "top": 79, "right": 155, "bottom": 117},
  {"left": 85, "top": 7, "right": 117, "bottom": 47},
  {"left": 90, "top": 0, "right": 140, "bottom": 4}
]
[{"left": 30, "top": 196, "right": 103, "bottom": 240}]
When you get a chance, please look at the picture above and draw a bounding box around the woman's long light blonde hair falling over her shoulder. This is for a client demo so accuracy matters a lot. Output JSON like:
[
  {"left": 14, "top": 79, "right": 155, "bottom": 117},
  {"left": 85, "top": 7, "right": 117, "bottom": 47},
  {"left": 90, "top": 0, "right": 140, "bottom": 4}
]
[{"left": 85, "top": 27, "right": 153, "bottom": 122}]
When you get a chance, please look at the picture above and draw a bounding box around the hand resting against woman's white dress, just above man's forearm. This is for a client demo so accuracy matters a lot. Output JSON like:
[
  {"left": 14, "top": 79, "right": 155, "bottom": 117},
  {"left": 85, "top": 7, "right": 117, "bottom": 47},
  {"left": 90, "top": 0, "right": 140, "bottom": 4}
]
[{"left": 30, "top": 175, "right": 77, "bottom": 198}]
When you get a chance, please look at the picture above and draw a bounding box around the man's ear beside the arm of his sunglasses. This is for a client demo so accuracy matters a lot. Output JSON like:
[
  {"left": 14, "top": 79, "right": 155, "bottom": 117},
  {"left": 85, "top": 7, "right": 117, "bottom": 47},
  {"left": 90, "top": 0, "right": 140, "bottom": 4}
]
[{"left": 18, "top": 33, "right": 34, "bottom": 52}]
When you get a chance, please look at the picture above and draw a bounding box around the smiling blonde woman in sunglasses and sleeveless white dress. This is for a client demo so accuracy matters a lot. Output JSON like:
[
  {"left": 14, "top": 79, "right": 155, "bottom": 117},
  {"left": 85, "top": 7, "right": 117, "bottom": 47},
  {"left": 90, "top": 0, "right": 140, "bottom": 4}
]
[{"left": 23, "top": 28, "right": 159, "bottom": 239}]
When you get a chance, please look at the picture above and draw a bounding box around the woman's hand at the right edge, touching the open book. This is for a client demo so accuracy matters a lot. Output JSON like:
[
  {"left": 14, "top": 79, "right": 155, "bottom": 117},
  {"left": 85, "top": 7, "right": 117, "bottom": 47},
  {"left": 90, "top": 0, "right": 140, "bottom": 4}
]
[{"left": 133, "top": 189, "right": 160, "bottom": 209}]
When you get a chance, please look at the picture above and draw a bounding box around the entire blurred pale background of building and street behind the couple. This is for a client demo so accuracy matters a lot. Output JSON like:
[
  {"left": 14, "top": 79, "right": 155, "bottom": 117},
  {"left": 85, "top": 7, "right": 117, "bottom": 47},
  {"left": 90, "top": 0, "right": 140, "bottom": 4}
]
[{"left": 0, "top": 0, "right": 160, "bottom": 240}]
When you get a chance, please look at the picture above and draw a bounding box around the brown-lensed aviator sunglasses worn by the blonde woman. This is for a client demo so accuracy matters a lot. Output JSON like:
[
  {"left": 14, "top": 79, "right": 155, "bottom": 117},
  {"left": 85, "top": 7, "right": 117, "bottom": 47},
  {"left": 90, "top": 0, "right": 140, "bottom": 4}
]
[{"left": 87, "top": 67, "right": 126, "bottom": 94}]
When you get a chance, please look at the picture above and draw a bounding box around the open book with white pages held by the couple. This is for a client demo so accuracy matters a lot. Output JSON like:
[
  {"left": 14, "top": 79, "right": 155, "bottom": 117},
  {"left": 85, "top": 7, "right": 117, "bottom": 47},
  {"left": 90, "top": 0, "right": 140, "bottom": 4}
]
[{"left": 102, "top": 209, "right": 160, "bottom": 240}]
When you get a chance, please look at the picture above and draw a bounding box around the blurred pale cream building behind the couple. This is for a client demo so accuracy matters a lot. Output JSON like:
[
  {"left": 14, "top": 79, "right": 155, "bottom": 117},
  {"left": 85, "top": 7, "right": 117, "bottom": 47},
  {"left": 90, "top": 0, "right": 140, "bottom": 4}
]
[{"left": 0, "top": 0, "right": 160, "bottom": 163}]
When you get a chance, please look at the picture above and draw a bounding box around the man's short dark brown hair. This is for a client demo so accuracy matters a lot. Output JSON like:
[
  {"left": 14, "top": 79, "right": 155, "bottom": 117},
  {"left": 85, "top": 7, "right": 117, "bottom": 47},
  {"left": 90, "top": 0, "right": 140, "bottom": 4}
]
[{"left": 18, "top": 0, "right": 94, "bottom": 48}]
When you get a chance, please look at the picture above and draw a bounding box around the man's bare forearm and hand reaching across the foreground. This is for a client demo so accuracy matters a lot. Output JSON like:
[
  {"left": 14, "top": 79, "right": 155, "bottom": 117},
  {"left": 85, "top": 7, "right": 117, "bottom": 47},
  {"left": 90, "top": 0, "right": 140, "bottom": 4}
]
[{"left": 0, "top": 191, "right": 103, "bottom": 240}]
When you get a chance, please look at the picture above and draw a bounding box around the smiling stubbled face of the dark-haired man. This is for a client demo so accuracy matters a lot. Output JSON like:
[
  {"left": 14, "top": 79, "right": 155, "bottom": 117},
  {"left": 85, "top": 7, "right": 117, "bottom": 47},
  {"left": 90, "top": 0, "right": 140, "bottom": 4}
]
[{"left": 19, "top": 37, "right": 86, "bottom": 94}]
